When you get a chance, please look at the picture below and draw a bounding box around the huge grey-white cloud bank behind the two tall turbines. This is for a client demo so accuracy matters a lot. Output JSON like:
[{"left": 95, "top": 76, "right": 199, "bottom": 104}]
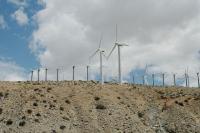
[{"left": 30, "top": 0, "right": 200, "bottom": 85}]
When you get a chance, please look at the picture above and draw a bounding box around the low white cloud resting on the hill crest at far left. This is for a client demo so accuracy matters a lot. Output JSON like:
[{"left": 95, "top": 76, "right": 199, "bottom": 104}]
[{"left": 0, "top": 60, "right": 27, "bottom": 81}]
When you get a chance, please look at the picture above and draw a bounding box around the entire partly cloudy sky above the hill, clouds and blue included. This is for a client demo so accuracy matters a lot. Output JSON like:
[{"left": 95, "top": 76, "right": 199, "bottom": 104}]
[{"left": 0, "top": 0, "right": 200, "bottom": 86}]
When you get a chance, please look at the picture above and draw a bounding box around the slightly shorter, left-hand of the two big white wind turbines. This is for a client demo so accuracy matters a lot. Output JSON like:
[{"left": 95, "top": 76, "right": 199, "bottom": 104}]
[{"left": 89, "top": 35, "right": 105, "bottom": 84}]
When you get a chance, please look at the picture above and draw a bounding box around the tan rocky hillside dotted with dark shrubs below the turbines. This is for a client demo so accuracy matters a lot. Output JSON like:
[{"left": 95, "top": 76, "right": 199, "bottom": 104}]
[{"left": 0, "top": 81, "right": 200, "bottom": 133}]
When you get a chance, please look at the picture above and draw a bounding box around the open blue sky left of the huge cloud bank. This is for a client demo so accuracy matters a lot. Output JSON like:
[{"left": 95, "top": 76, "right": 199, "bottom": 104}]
[{"left": 0, "top": 0, "right": 42, "bottom": 70}]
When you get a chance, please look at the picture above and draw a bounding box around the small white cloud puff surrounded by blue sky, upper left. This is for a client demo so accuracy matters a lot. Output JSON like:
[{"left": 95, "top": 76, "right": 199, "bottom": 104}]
[{"left": 11, "top": 7, "right": 29, "bottom": 26}]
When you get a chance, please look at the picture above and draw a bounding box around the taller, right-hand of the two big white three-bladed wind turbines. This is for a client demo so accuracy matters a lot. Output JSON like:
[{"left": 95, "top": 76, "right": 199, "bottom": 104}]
[{"left": 107, "top": 25, "right": 128, "bottom": 84}]
